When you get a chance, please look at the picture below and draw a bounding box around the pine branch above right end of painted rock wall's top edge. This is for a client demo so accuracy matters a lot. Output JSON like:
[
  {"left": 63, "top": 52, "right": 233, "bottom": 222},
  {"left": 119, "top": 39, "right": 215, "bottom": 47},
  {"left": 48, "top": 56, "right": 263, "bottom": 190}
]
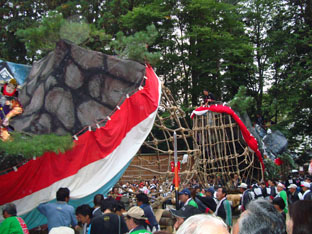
[{"left": 110, "top": 25, "right": 160, "bottom": 64}]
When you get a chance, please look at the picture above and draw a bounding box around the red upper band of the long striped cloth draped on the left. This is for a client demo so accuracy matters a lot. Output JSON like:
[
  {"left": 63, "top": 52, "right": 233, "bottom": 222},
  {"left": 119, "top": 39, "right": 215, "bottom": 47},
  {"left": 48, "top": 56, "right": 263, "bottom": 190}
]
[{"left": 0, "top": 65, "right": 159, "bottom": 205}]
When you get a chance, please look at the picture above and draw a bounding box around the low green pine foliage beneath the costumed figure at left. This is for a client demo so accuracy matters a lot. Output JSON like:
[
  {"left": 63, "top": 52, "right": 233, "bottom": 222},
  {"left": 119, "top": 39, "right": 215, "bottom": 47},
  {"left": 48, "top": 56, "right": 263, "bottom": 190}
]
[{"left": 0, "top": 132, "right": 73, "bottom": 158}]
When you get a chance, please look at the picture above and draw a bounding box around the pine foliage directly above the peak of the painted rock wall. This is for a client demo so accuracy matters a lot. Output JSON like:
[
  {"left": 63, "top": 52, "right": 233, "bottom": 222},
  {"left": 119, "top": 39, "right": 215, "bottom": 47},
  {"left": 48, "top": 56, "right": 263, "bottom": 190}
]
[{"left": 16, "top": 11, "right": 111, "bottom": 59}]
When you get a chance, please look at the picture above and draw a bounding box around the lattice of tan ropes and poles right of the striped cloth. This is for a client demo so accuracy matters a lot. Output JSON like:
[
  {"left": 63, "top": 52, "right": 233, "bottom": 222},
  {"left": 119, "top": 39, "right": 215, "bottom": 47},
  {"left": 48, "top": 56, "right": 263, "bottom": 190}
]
[{"left": 124, "top": 85, "right": 264, "bottom": 187}]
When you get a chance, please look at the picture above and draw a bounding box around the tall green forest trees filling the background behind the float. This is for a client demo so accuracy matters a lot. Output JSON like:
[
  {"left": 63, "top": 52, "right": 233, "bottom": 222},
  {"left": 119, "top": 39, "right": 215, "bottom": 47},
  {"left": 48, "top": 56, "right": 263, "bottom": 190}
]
[{"left": 0, "top": 0, "right": 312, "bottom": 163}]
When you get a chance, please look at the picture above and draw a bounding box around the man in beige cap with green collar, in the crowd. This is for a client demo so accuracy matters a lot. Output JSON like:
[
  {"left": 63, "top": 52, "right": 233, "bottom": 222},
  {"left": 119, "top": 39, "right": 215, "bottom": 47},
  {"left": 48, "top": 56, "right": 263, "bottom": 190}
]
[{"left": 124, "top": 206, "right": 152, "bottom": 234}]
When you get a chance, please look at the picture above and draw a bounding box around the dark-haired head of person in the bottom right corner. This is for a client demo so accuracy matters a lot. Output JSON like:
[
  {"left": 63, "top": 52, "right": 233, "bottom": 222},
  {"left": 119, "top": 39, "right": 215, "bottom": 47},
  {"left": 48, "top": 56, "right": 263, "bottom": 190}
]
[{"left": 287, "top": 200, "right": 312, "bottom": 234}]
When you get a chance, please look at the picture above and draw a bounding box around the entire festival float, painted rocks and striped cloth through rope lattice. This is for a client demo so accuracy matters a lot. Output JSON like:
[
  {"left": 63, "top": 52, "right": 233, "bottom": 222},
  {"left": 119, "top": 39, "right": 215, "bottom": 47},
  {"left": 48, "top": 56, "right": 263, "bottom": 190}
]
[{"left": 0, "top": 40, "right": 288, "bottom": 228}]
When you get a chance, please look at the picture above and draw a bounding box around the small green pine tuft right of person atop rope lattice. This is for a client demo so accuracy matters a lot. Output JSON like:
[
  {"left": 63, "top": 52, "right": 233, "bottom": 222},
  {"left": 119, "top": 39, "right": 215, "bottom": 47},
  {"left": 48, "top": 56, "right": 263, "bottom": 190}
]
[{"left": 229, "top": 86, "right": 254, "bottom": 114}]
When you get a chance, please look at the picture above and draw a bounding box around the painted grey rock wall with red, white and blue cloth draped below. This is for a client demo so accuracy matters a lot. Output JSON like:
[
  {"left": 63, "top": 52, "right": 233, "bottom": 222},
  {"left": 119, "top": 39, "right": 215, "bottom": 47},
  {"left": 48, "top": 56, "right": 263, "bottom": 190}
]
[{"left": 0, "top": 40, "right": 161, "bottom": 229}]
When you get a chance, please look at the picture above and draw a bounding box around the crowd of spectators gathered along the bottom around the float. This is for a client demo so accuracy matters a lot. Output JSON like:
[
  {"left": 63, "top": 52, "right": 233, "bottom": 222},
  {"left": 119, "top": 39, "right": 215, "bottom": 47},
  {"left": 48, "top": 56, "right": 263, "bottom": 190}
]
[{"left": 0, "top": 174, "right": 312, "bottom": 234}]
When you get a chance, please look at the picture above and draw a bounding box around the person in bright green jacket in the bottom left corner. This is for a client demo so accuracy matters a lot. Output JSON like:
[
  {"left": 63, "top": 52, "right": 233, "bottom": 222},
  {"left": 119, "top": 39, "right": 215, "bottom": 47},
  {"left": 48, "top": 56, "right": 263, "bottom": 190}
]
[{"left": 0, "top": 203, "right": 29, "bottom": 234}]
